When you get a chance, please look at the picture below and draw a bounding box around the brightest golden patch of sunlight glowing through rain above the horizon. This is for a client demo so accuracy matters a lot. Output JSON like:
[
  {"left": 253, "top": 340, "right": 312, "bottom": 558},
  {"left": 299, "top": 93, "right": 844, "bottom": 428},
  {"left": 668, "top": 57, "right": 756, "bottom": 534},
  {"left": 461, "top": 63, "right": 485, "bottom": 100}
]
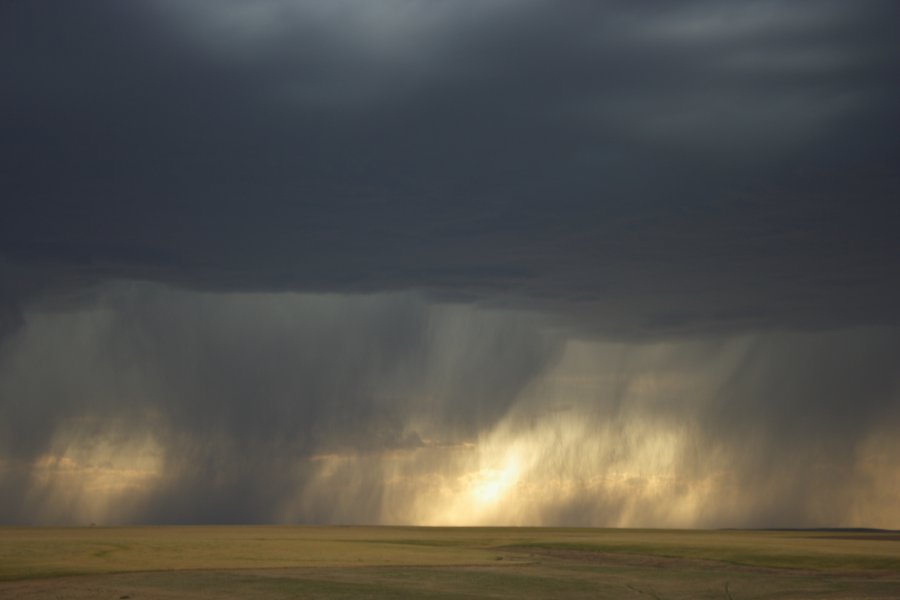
[{"left": 376, "top": 413, "right": 704, "bottom": 526}]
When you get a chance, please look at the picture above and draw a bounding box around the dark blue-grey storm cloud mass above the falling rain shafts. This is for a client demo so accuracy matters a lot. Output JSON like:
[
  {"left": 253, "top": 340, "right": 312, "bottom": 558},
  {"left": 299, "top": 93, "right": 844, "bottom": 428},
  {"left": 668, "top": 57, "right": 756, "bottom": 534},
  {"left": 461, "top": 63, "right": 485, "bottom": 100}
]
[{"left": 0, "top": 0, "right": 900, "bottom": 335}]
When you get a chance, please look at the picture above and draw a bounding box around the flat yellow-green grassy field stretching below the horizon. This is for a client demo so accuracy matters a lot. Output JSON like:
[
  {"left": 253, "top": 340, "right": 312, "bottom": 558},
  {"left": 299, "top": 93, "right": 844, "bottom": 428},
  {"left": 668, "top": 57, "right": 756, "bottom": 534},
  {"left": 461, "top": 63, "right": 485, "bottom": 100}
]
[{"left": 0, "top": 526, "right": 900, "bottom": 600}]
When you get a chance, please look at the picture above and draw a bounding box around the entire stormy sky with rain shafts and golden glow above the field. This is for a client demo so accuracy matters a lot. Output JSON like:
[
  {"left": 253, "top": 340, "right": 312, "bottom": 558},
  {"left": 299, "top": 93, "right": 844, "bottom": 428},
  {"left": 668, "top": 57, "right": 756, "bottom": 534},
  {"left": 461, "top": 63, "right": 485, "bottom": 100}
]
[{"left": 0, "top": 0, "right": 900, "bottom": 527}]
